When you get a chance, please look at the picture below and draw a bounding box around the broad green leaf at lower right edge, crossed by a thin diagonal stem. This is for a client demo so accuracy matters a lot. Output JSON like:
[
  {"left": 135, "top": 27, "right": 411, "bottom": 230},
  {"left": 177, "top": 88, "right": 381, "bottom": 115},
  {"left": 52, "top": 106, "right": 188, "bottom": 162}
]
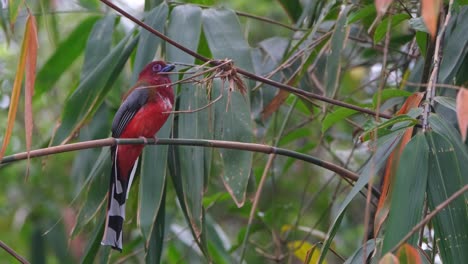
[{"left": 426, "top": 132, "right": 468, "bottom": 263}]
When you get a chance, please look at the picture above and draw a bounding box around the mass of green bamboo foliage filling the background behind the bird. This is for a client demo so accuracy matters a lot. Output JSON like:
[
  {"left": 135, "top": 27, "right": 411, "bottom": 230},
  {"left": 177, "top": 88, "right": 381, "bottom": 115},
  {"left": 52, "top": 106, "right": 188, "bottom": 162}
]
[{"left": 0, "top": 0, "right": 468, "bottom": 263}]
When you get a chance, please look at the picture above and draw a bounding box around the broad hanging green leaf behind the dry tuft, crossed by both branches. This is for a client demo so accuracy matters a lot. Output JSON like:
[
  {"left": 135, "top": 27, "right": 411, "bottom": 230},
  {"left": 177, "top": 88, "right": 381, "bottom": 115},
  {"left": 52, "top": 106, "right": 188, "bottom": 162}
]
[{"left": 203, "top": 9, "right": 253, "bottom": 206}]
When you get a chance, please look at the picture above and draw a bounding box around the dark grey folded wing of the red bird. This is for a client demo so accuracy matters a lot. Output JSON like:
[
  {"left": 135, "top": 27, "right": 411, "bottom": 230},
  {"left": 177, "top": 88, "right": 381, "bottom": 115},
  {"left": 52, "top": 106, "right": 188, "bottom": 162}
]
[{"left": 112, "top": 85, "right": 149, "bottom": 138}]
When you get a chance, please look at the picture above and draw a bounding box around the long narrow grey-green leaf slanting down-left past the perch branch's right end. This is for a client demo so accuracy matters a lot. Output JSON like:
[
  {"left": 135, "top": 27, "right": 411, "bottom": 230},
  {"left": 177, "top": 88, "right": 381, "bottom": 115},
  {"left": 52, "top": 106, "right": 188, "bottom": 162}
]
[{"left": 319, "top": 130, "right": 404, "bottom": 263}]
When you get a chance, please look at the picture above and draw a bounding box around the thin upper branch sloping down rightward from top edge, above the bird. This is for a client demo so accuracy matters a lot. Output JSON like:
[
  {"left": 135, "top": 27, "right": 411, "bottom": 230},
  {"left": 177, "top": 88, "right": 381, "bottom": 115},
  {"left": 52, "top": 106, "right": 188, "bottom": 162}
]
[{"left": 101, "top": 0, "right": 392, "bottom": 119}]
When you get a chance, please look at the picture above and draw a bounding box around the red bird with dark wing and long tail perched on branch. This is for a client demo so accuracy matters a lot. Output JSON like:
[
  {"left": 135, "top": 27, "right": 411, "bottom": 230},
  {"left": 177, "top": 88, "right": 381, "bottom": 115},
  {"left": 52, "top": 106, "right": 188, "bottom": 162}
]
[{"left": 101, "top": 60, "right": 175, "bottom": 252}]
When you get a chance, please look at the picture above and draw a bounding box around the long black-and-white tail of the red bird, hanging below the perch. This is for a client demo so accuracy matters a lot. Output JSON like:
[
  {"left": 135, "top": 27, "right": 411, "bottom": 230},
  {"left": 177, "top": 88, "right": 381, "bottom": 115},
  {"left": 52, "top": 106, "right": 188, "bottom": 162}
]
[{"left": 101, "top": 146, "right": 138, "bottom": 251}]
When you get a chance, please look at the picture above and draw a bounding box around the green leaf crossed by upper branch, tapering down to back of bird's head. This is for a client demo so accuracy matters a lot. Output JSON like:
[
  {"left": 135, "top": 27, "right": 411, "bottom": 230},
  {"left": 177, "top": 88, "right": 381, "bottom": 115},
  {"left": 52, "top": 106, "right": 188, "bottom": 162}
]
[{"left": 131, "top": 2, "right": 169, "bottom": 83}]
